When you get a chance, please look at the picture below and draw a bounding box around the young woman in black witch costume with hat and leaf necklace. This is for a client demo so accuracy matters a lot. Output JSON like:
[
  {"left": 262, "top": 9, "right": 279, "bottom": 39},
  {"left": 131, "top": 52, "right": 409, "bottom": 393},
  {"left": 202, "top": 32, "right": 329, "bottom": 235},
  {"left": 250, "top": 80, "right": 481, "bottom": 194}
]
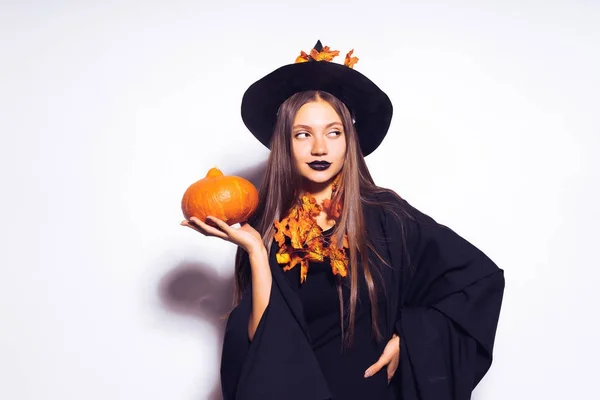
[{"left": 182, "top": 42, "right": 504, "bottom": 400}]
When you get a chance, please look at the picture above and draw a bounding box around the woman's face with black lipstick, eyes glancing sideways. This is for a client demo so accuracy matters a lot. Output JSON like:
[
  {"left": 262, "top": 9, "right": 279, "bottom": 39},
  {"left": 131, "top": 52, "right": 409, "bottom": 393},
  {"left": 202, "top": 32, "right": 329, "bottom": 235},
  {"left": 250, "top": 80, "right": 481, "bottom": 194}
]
[{"left": 292, "top": 100, "right": 346, "bottom": 188}]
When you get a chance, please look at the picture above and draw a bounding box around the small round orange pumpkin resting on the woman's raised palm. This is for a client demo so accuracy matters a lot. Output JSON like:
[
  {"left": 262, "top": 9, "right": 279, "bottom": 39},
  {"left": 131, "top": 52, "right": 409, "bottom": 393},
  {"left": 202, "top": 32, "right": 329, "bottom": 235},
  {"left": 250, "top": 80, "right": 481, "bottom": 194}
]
[{"left": 181, "top": 168, "right": 258, "bottom": 225}]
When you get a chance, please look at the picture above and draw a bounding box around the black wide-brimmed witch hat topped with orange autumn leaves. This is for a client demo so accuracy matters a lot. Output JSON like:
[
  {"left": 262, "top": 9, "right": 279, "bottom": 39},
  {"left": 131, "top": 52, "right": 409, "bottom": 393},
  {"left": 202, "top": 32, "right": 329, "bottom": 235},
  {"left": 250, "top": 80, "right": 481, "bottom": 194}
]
[{"left": 242, "top": 41, "right": 392, "bottom": 156}]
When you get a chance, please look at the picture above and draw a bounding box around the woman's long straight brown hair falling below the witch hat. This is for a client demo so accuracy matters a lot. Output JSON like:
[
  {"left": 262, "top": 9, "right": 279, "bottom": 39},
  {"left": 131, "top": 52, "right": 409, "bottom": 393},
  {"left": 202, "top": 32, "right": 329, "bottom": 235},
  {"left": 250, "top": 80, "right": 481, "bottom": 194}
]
[{"left": 235, "top": 91, "right": 410, "bottom": 345}]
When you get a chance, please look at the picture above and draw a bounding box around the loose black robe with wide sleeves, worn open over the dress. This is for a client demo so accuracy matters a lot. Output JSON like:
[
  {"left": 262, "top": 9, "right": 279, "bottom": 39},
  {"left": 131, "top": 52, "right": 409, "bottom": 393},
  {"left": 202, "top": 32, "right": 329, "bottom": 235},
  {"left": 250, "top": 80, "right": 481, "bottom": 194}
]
[{"left": 221, "top": 195, "right": 504, "bottom": 400}]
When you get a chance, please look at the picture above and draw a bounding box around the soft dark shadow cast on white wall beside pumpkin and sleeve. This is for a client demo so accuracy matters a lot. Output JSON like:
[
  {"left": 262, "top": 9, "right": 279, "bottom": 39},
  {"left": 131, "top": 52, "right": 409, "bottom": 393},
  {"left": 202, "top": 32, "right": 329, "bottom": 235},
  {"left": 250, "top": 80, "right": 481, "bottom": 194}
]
[{"left": 158, "top": 162, "right": 266, "bottom": 400}]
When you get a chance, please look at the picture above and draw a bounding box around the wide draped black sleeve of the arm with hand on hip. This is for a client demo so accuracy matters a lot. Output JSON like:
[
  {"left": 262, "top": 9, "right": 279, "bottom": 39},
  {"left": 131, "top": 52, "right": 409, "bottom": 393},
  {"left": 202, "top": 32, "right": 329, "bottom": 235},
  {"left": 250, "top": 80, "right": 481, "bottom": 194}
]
[{"left": 384, "top": 200, "right": 504, "bottom": 400}]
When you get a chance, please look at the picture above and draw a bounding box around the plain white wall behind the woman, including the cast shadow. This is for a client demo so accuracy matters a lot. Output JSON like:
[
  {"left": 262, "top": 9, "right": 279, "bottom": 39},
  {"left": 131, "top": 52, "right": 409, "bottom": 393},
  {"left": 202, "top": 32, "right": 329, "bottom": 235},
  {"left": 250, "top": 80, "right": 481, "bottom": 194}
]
[{"left": 0, "top": 0, "right": 600, "bottom": 400}]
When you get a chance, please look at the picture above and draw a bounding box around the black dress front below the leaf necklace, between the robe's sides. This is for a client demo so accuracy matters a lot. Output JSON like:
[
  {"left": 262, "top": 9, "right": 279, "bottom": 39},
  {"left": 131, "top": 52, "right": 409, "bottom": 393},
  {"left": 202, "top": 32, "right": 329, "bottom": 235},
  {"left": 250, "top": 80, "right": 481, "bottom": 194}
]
[{"left": 282, "top": 228, "right": 391, "bottom": 400}]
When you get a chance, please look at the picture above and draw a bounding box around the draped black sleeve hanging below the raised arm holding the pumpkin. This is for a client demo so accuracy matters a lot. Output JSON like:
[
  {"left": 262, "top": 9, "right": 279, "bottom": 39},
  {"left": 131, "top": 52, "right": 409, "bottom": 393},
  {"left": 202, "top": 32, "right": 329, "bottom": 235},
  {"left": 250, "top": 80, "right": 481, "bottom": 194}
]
[{"left": 221, "top": 248, "right": 331, "bottom": 400}]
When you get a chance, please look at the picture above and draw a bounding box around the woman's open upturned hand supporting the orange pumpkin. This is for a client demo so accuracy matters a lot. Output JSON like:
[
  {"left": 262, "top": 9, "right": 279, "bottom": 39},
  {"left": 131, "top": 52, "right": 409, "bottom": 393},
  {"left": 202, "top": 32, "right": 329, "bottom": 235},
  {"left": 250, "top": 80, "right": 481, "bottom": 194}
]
[{"left": 181, "top": 216, "right": 265, "bottom": 254}]
